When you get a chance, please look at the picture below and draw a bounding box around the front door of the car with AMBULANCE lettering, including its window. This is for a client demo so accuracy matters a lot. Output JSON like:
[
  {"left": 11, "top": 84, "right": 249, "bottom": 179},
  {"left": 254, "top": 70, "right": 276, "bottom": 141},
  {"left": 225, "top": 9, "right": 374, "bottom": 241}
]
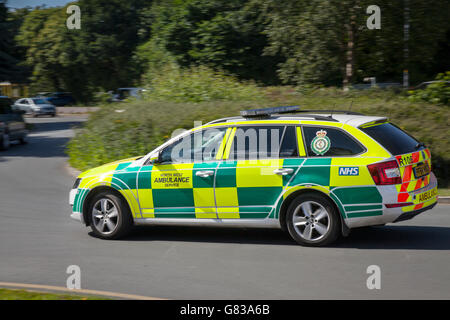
[{"left": 138, "top": 127, "right": 229, "bottom": 219}]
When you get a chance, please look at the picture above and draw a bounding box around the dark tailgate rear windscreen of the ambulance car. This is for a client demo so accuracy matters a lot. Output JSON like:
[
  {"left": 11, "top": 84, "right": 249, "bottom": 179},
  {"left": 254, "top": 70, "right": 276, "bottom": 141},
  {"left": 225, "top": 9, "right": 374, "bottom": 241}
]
[{"left": 360, "top": 122, "right": 423, "bottom": 156}]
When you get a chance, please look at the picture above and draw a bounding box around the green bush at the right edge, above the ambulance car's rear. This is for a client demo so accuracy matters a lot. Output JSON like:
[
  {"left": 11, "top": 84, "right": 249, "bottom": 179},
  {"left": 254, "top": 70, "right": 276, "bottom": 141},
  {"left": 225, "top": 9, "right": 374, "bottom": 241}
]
[{"left": 408, "top": 71, "right": 450, "bottom": 105}]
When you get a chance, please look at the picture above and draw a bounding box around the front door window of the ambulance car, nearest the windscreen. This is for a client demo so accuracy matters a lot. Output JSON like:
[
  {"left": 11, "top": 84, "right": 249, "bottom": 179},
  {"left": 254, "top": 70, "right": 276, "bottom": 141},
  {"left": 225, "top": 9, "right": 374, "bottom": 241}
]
[{"left": 161, "top": 128, "right": 227, "bottom": 163}]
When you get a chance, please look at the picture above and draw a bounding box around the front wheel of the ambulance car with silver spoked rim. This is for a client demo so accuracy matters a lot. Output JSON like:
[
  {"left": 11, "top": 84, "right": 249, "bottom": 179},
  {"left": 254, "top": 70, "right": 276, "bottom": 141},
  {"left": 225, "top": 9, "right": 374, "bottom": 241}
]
[{"left": 89, "top": 191, "right": 133, "bottom": 239}]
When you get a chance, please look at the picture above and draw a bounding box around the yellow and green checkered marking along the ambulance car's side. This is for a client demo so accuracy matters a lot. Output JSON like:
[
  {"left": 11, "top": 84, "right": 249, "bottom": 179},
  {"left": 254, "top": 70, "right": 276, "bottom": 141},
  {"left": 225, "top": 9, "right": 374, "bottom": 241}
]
[{"left": 74, "top": 158, "right": 381, "bottom": 219}]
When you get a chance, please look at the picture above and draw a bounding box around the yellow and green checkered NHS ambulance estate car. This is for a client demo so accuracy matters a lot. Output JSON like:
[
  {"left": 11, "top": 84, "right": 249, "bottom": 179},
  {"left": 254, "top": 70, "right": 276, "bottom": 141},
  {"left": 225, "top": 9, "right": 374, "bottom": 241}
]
[{"left": 70, "top": 106, "right": 437, "bottom": 246}]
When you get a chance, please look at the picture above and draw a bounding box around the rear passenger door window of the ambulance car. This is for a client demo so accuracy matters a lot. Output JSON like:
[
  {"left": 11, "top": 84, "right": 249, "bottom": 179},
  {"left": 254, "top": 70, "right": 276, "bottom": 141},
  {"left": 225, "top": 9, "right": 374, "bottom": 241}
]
[{"left": 228, "top": 126, "right": 298, "bottom": 160}]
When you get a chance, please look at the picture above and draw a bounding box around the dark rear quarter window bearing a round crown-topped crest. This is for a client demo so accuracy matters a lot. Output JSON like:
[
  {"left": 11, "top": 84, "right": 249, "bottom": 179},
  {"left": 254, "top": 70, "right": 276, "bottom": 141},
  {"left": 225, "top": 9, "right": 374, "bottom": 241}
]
[{"left": 303, "top": 126, "right": 364, "bottom": 157}]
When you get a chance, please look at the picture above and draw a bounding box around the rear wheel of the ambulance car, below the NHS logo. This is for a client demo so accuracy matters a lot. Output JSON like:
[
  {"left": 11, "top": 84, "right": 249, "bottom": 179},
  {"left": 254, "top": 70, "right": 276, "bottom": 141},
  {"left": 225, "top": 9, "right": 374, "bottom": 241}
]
[{"left": 286, "top": 193, "right": 341, "bottom": 247}]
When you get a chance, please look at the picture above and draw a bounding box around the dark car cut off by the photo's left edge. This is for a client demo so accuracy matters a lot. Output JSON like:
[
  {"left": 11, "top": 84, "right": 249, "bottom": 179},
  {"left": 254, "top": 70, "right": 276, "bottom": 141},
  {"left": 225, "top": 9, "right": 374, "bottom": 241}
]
[{"left": 0, "top": 96, "right": 28, "bottom": 150}]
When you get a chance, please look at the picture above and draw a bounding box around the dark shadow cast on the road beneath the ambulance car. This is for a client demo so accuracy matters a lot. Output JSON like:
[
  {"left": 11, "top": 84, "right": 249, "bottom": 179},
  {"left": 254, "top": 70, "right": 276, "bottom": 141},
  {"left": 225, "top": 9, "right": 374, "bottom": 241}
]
[{"left": 101, "top": 225, "right": 450, "bottom": 250}]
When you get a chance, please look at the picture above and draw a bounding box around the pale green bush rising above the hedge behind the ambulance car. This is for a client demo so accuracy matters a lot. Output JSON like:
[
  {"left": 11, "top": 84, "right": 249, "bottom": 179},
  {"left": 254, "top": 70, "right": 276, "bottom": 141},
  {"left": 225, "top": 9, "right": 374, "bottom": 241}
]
[{"left": 146, "top": 64, "right": 261, "bottom": 102}]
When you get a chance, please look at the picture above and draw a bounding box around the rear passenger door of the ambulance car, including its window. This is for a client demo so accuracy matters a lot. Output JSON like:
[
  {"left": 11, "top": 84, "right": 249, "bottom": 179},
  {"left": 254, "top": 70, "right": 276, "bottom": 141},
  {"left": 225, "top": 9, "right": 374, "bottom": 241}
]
[{"left": 215, "top": 125, "right": 303, "bottom": 219}]
